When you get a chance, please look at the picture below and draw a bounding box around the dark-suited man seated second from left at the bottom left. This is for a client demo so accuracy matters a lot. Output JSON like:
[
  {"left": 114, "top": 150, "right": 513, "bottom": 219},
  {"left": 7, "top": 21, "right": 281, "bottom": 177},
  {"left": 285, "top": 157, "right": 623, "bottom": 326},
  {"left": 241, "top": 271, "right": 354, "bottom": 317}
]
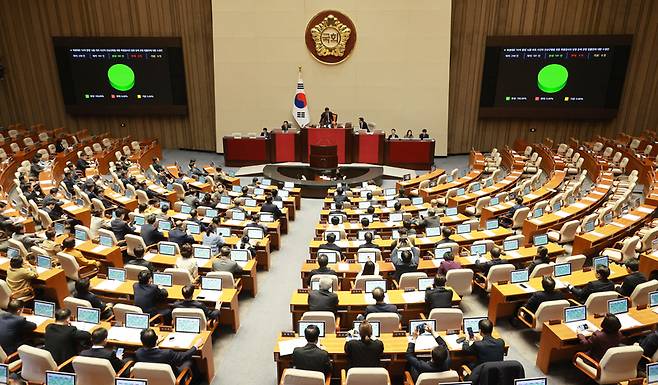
[{"left": 44, "top": 309, "right": 91, "bottom": 365}]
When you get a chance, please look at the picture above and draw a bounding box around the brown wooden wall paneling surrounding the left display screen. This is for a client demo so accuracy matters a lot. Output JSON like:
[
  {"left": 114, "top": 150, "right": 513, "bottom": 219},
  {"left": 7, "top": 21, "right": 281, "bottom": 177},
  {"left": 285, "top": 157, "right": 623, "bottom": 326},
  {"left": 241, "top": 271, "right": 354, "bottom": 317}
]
[{"left": 0, "top": 0, "right": 215, "bottom": 151}]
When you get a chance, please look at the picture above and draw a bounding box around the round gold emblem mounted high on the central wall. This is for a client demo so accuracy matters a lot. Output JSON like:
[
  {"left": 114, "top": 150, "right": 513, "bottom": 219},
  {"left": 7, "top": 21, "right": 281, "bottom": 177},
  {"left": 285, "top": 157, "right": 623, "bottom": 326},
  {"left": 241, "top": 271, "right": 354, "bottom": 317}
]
[{"left": 306, "top": 10, "right": 356, "bottom": 64}]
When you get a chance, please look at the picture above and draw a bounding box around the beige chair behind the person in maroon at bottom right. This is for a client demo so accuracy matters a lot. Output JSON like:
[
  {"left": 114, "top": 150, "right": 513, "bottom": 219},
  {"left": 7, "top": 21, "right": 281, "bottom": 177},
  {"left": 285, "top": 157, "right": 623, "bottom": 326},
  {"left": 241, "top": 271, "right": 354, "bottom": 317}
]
[{"left": 573, "top": 344, "right": 643, "bottom": 384}]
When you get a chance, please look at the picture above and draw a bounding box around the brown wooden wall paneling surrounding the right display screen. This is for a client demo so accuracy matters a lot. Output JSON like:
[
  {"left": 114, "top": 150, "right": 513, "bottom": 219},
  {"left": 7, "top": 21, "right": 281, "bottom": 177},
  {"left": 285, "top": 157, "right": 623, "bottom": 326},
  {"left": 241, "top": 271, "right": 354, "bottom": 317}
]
[{"left": 448, "top": 0, "right": 658, "bottom": 153}]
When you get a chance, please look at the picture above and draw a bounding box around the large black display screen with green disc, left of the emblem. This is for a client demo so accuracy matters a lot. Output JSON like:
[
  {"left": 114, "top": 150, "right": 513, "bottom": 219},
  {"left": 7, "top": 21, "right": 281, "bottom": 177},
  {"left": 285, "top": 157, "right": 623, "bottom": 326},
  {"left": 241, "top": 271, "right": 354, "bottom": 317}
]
[{"left": 53, "top": 37, "right": 187, "bottom": 115}]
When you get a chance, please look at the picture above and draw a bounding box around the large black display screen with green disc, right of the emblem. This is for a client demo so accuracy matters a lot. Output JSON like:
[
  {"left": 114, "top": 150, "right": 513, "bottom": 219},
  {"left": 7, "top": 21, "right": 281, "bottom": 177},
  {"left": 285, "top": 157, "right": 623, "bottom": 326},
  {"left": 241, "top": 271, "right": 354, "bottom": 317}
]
[{"left": 480, "top": 35, "right": 632, "bottom": 119}]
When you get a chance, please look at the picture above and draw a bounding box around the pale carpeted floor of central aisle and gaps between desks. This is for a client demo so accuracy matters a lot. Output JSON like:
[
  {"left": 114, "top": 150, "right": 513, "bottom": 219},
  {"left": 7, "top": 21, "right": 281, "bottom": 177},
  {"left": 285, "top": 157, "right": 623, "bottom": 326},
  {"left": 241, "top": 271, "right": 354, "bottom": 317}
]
[{"left": 159, "top": 150, "right": 587, "bottom": 385}]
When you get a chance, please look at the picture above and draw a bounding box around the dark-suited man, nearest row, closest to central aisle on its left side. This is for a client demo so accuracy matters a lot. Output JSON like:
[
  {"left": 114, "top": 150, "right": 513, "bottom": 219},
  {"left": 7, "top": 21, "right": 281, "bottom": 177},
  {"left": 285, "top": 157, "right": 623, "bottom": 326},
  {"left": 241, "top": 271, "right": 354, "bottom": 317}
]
[{"left": 135, "top": 329, "right": 203, "bottom": 376}]
